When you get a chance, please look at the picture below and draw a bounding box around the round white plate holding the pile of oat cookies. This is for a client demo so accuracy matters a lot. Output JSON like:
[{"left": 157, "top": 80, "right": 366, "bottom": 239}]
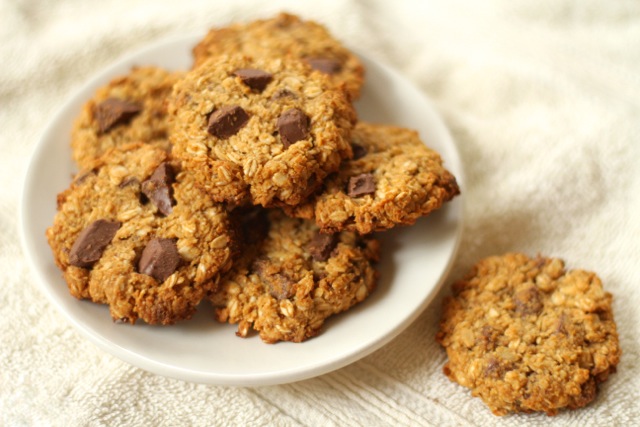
[{"left": 21, "top": 36, "right": 462, "bottom": 386}]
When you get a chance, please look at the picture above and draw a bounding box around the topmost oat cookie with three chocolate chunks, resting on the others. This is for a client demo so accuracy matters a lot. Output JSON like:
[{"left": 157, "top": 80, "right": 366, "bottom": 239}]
[{"left": 169, "top": 56, "right": 356, "bottom": 207}]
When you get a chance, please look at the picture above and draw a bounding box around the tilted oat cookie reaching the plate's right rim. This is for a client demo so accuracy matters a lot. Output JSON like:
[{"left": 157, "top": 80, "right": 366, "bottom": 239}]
[{"left": 284, "top": 122, "right": 460, "bottom": 234}]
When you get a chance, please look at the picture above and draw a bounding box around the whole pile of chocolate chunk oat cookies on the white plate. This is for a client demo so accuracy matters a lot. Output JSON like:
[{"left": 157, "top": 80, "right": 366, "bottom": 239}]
[{"left": 47, "top": 14, "right": 459, "bottom": 343}]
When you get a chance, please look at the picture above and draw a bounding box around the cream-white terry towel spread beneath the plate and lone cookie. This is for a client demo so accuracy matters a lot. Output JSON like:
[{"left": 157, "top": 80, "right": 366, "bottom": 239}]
[{"left": 0, "top": 0, "right": 640, "bottom": 426}]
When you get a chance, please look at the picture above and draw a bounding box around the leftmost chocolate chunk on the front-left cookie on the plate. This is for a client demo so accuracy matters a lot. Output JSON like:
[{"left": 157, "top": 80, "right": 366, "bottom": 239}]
[{"left": 69, "top": 219, "right": 121, "bottom": 268}]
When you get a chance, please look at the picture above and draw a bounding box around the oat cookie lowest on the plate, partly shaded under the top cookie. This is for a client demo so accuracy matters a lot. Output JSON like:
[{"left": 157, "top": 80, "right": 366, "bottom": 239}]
[{"left": 211, "top": 210, "right": 379, "bottom": 343}]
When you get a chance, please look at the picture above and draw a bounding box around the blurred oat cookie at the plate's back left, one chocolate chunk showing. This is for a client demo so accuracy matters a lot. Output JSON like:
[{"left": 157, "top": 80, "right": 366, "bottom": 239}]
[{"left": 71, "top": 67, "right": 181, "bottom": 169}]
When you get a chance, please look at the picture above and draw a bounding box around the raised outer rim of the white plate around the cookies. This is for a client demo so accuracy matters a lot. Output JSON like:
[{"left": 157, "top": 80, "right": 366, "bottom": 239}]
[{"left": 18, "top": 33, "right": 465, "bottom": 386}]
